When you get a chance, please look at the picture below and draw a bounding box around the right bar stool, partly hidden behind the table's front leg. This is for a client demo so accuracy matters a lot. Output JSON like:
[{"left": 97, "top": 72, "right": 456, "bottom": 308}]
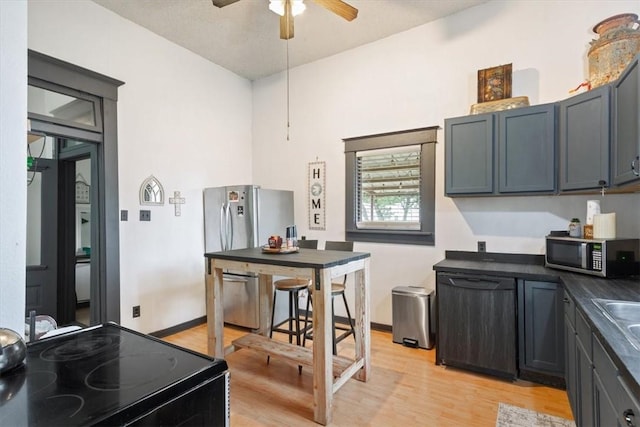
[{"left": 302, "top": 241, "right": 356, "bottom": 355}]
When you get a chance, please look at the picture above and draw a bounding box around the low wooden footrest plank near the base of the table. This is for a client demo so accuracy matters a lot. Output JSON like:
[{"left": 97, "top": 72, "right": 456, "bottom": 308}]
[{"left": 232, "top": 334, "right": 353, "bottom": 378}]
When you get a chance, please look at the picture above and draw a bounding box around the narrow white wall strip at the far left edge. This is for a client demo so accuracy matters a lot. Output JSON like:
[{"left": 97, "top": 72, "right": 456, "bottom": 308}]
[{"left": 0, "top": 1, "right": 27, "bottom": 336}]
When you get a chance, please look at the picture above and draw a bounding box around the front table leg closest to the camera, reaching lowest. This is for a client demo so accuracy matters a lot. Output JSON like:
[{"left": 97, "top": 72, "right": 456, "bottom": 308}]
[{"left": 313, "top": 270, "right": 333, "bottom": 425}]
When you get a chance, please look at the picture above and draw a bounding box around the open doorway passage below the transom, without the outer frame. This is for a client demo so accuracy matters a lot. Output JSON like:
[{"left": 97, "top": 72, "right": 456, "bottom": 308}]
[{"left": 26, "top": 135, "right": 101, "bottom": 326}]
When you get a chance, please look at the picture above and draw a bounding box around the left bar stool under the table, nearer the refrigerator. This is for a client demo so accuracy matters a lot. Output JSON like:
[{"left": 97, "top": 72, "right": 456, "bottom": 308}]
[{"left": 267, "top": 240, "right": 318, "bottom": 371}]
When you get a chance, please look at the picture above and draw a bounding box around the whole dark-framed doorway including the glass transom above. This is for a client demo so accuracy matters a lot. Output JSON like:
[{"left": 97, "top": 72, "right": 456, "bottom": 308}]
[{"left": 27, "top": 50, "right": 123, "bottom": 325}]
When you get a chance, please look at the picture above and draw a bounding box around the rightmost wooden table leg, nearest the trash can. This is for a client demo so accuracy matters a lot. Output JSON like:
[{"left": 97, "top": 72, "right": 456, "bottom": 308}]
[{"left": 355, "top": 259, "right": 371, "bottom": 381}]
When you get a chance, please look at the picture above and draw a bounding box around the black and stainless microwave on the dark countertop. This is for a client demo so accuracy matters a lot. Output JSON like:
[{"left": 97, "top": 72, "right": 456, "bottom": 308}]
[{"left": 545, "top": 236, "right": 640, "bottom": 277}]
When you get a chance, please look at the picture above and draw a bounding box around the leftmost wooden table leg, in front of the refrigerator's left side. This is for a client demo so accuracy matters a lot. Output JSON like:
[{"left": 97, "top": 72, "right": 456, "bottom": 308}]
[{"left": 206, "top": 259, "right": 224, "bottom": 358}]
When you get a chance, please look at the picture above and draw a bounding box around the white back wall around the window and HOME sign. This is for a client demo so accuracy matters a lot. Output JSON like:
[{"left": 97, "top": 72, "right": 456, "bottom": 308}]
[{"left": 253, "top": 1, "right": 640, "bottom": 324}]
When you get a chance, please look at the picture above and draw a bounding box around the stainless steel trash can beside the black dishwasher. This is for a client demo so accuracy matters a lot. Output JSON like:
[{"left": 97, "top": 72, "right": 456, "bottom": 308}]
[{"left": 391, "top": 286, "right": 434, "bottom": 349}]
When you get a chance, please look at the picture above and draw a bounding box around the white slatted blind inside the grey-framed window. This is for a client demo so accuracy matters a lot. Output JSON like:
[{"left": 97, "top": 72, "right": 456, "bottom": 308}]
[{"left": 356, "top": 145, "right": 421, "bottom": 230}]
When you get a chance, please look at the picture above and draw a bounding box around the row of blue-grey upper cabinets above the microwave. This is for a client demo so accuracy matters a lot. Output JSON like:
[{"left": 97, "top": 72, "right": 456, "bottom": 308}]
[{"left": 444, "top": 55, "right": 640, "bottom": 197}]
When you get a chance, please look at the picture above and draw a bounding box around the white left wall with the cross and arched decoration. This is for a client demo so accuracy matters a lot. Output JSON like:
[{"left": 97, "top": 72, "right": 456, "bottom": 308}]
[{"left": 28, "top": 0, "right": 252, "bottom": 332}]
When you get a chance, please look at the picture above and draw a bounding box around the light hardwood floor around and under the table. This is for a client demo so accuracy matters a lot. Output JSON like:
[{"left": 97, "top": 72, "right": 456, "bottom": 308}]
[{"left": 165, "top": 325, "right": 573, "bottom": 427}]
